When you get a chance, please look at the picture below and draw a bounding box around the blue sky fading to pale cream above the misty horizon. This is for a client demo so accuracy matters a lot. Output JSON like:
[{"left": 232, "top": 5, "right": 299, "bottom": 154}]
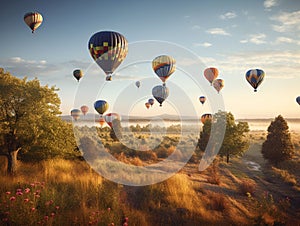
[{"left": 0, "top": 0, "right": 300, "bottom": 118}]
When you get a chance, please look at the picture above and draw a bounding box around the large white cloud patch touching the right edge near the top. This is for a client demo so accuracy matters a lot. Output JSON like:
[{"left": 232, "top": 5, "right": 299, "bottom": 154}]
[{"left": 271, "top": 10, "right": 300, "bottom": 32}]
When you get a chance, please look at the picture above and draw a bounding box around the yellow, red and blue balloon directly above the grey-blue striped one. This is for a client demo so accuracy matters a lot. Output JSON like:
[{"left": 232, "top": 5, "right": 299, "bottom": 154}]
[{"left": 152, "top": 55, "right": 176, "bottom": 85}]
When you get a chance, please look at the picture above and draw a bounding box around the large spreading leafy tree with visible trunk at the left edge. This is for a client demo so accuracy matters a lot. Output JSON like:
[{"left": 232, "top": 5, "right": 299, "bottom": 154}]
[{"left": 0, "top": 69, "right": 76, "bottom": 174}]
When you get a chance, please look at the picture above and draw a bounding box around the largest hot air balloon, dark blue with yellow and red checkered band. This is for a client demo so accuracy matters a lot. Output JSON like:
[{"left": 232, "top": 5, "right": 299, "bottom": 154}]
[{"left": 88, "top": 31, "right": 128, "bottom": 81}]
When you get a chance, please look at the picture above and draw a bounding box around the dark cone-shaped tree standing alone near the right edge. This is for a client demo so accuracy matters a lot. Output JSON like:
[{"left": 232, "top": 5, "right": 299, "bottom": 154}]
[{"left": 261, "top": 115, "right": 294, "bottom": 164}]
